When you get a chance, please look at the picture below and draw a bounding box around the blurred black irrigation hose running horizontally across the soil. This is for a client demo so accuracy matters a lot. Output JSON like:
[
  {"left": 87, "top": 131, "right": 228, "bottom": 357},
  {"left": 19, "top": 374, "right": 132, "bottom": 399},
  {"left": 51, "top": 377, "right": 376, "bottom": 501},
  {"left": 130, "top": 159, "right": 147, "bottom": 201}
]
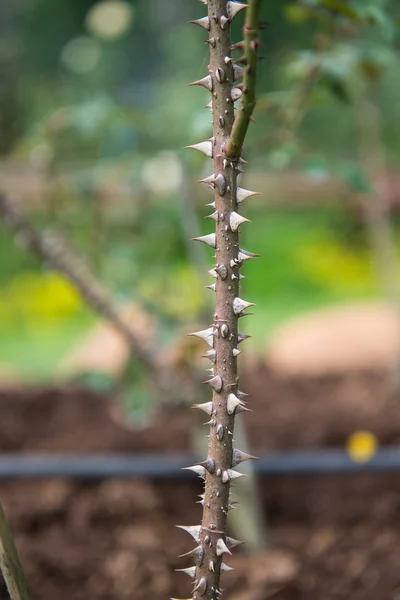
[{"left": 0, "top": 448, "right": 400, "bottom": 480}]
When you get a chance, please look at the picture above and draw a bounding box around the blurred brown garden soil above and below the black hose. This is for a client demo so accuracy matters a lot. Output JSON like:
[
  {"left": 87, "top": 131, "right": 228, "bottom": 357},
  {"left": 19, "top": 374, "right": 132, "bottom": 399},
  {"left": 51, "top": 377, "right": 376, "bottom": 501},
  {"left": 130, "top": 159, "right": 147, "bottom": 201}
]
[{"left": 0, "top": 366, "right": 400, "bottom": 600}]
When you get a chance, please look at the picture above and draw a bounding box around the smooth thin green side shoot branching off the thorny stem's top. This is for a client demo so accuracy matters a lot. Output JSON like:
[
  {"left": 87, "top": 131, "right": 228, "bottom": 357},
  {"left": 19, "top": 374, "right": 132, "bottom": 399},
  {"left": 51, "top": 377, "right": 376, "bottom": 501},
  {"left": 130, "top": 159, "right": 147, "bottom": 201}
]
[{"left": 226, "top": 0, "right": 261, "bottom": 158}]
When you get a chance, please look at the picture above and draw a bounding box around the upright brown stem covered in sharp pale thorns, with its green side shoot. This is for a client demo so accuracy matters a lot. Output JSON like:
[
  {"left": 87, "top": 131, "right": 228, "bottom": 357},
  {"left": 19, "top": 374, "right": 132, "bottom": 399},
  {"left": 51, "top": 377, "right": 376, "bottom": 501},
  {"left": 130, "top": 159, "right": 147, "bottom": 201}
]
[{"left": 182, "top": 0, "right": 259, "bottom": 600}]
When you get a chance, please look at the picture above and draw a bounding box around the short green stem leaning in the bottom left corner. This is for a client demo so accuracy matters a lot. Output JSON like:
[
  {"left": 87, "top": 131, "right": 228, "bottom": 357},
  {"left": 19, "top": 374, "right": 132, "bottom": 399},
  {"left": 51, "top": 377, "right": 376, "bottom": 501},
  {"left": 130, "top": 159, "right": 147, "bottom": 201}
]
[{"left": 0, "top": 502, "right": 31, "bottom": 600}]
